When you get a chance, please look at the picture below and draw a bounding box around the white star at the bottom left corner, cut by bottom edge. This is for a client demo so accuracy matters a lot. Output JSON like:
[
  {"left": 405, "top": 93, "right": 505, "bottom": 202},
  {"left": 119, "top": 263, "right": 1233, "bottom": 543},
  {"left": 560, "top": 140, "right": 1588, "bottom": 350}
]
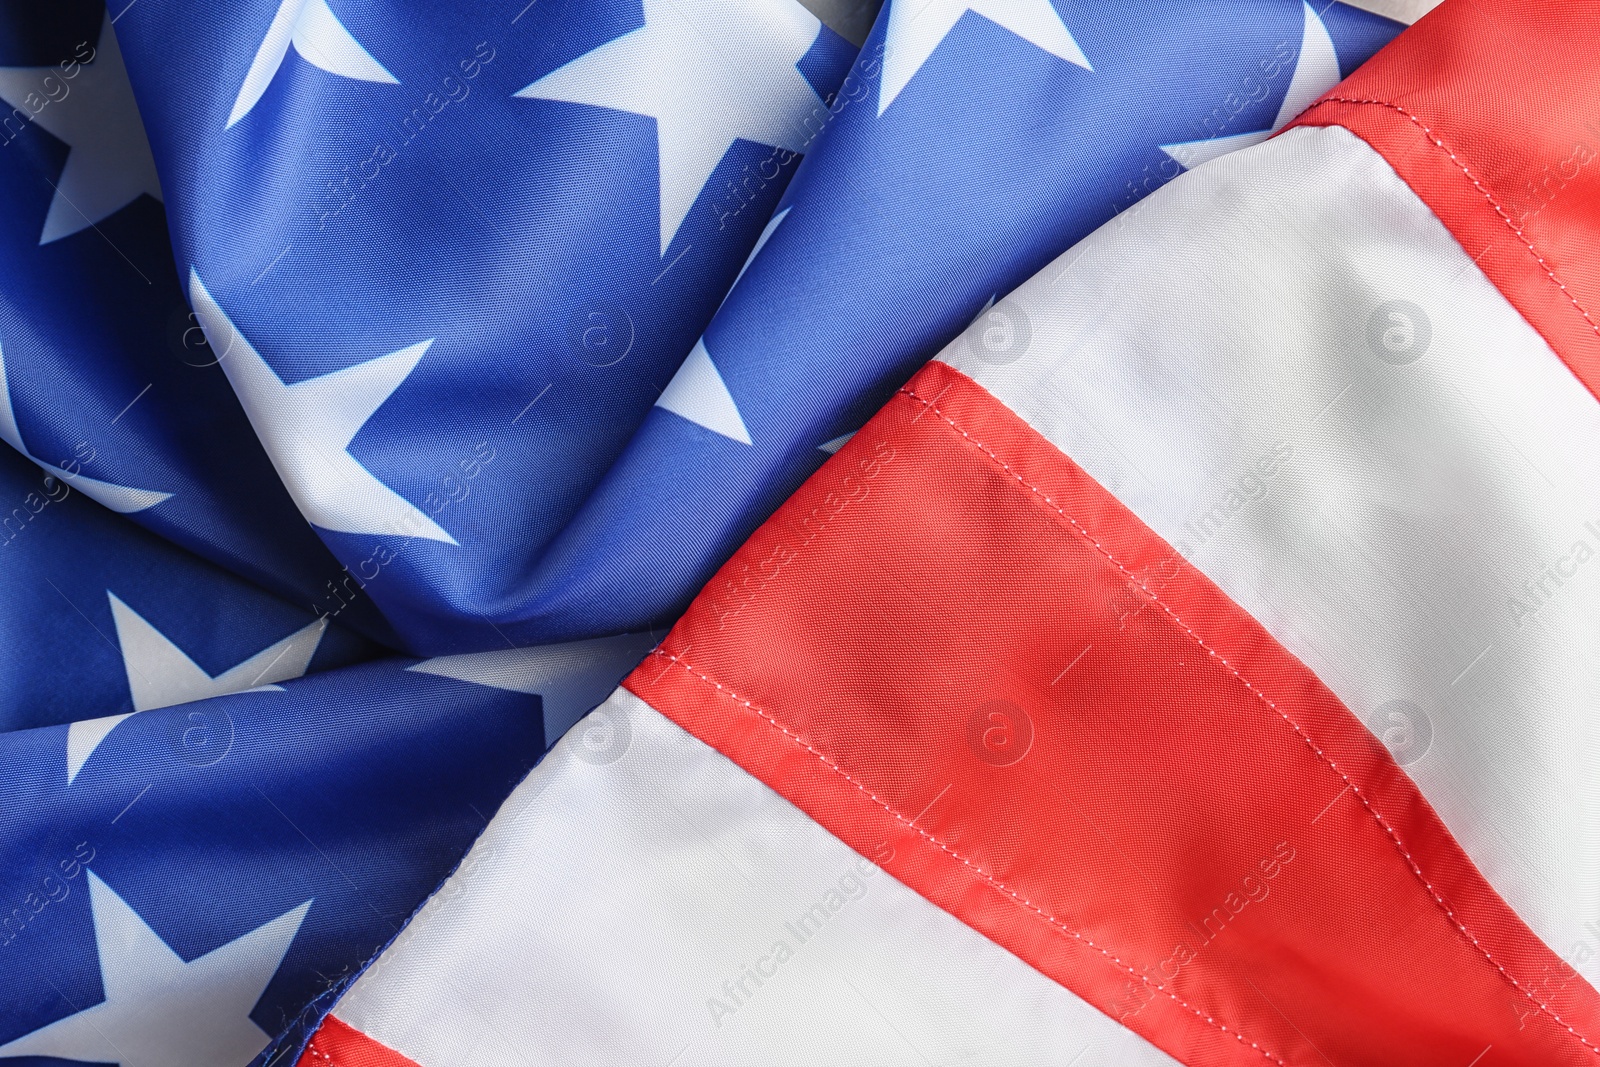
[{"left": 0, "top": 872, "right": 310, "bottom": 1067}]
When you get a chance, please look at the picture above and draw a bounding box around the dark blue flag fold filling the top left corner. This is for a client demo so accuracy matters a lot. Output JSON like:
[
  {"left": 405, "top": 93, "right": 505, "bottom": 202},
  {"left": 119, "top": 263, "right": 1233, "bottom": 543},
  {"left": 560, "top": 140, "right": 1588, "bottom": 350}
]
[{"left": 0, "top": 0, "right": 387, "bottom": 640}]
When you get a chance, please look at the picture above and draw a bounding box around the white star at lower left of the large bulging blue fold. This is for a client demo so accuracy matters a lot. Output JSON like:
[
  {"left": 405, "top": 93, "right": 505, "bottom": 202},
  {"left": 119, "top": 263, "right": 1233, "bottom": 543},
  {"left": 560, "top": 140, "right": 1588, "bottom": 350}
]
[{"left": 189, "top": 270, "right": 456, "bottom": 544}]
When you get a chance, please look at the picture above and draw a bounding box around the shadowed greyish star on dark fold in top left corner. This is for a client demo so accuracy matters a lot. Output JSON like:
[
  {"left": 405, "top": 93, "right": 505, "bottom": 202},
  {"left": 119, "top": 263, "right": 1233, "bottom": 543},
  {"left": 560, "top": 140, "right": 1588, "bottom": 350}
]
[{"left": 0, "top": 13, "right": 162, "bottom": 245}]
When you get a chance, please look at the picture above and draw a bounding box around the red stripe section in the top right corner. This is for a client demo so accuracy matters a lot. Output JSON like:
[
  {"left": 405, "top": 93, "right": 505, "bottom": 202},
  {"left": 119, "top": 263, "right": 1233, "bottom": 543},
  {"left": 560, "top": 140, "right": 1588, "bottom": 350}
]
[{"left": 1294, "top": 0, "right": 1600, "bottom": 404}]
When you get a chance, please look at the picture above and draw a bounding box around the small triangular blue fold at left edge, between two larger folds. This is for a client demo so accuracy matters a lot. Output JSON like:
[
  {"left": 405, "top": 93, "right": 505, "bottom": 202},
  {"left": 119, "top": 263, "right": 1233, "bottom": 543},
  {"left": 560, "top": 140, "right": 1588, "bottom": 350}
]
[{"left": 0, "top": 448, "right": 382, "bottom": 735}]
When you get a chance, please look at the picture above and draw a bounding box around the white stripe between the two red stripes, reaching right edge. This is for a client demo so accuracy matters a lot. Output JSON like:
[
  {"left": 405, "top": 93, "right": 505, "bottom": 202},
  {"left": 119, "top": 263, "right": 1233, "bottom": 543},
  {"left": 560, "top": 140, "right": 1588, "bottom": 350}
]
[{"left": 944, "top": 128, "right": 1600, "bottom": 981}]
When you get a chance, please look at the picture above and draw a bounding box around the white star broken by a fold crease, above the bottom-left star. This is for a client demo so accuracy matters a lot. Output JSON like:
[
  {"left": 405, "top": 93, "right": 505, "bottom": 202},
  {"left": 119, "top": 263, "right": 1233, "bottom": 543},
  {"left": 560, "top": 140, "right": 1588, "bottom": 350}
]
[{"left": 67, "top": 589, "right": 328, "bottom": 785}]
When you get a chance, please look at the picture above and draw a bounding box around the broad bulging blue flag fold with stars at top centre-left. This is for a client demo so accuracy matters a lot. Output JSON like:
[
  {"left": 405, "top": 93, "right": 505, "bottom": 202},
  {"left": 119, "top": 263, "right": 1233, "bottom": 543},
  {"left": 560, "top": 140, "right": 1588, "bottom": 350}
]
[{"left": 106, "top": 0, "right": 856, "bottom": 654}]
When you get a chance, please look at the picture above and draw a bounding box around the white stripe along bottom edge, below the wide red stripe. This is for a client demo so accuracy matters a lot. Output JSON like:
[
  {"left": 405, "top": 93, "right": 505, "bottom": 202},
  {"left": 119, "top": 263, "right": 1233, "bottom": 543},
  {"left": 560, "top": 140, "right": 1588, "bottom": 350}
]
[{"left": 334, "top": 689, "right": 1176, "bottom": 1067}]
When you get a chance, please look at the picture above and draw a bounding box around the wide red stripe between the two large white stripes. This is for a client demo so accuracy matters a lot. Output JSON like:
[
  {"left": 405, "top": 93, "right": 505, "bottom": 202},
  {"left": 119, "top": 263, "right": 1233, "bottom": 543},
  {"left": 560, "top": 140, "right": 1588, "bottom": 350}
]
[{"left": 626, "top": 363, "right": 1600, "bottom": 1067}]
